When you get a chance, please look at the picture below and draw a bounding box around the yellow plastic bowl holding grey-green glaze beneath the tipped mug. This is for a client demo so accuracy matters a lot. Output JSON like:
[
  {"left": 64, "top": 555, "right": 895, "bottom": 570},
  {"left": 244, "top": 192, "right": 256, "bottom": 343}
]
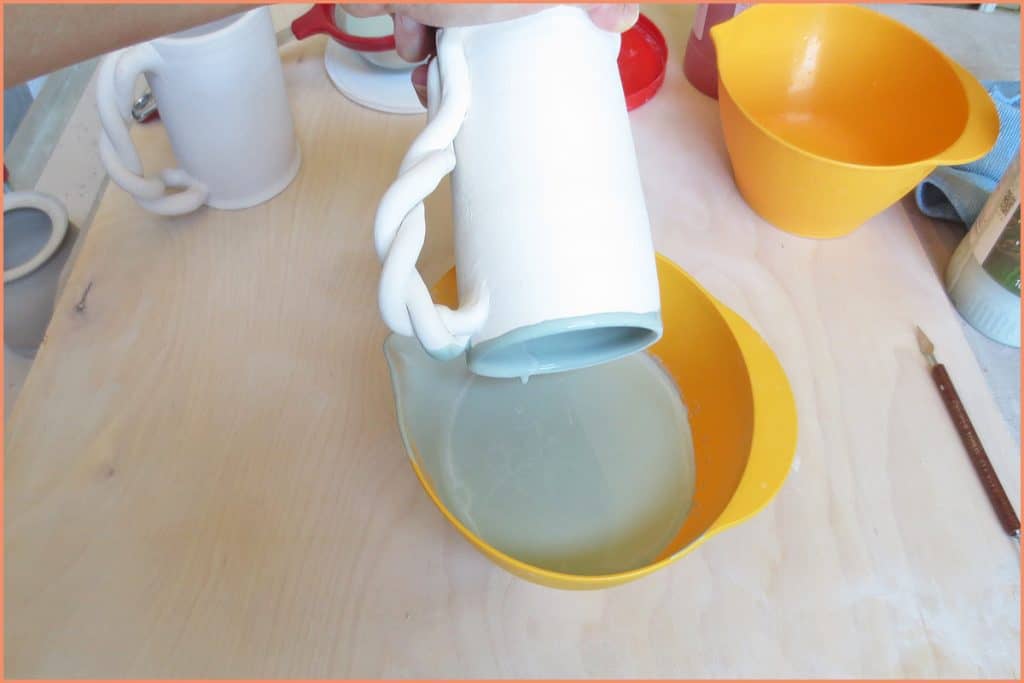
[{"left": 391, "top": 255, "right": 797, "bottom": 589}]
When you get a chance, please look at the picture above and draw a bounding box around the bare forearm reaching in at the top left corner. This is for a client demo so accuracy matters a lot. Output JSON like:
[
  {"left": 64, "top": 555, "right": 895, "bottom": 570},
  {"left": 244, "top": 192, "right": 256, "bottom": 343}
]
[{"left": 3, "top": 4, "right": 255, "bottom": 87}]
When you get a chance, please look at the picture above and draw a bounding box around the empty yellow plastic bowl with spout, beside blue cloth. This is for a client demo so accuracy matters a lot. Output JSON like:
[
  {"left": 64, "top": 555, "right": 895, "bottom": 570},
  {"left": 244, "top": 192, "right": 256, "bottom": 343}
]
[{"left": 711, "top": 4, "right": 999, "bottom": 238}]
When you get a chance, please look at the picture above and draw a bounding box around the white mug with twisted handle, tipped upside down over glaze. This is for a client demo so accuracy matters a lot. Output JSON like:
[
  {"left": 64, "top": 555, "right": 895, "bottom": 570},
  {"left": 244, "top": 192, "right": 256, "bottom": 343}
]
[{"left": 375, "top": 6, "right": 662, "bottom": 377}]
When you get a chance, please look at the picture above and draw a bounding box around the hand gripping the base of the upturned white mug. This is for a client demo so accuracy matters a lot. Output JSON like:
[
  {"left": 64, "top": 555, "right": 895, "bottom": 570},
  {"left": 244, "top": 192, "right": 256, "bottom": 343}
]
[{"left": 341, "top": 3, "right": 640, "bottom": 105}]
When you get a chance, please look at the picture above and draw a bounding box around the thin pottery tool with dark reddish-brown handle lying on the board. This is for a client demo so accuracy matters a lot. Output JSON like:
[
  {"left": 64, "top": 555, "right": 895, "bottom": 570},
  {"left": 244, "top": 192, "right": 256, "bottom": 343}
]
[{"left": 914, "top": 327, "right": 1021, "bottom": 543}]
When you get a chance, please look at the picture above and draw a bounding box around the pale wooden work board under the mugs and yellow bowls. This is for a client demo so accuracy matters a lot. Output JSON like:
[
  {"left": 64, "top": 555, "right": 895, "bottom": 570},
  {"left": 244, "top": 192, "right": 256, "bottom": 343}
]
[{"left": 5, "top": 7, "right": 1020, "bottom": 678}]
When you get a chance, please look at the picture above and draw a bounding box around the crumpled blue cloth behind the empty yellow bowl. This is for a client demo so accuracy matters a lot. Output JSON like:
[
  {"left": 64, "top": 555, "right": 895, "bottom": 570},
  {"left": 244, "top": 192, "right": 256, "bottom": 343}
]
[{"left": 914, "top": 81, "right": 1021, "bottom": 226}]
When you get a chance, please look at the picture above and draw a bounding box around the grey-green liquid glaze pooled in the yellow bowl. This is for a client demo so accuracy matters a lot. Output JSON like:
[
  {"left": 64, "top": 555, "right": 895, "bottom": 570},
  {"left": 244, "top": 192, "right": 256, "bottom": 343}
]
[{"left": 386, "top": 337, "right": 695, "bottom": 574}]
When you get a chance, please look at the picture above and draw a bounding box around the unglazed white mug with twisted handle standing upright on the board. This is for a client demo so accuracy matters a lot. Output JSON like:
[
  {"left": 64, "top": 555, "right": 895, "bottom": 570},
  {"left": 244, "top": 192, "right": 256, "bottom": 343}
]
[{"left": 96, "top": 7, "right": 300, "bottom": 215}]
